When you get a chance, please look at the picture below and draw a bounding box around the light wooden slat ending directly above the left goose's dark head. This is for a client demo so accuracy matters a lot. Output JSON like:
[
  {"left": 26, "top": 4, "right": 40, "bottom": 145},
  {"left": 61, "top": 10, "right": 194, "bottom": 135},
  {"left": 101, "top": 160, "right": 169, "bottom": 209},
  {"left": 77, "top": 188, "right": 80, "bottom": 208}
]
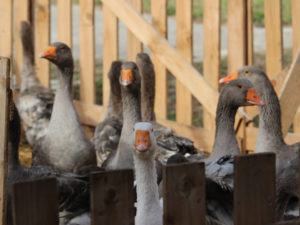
[{"left": 57, "top": 0, "right": 72, "bottom": 48}]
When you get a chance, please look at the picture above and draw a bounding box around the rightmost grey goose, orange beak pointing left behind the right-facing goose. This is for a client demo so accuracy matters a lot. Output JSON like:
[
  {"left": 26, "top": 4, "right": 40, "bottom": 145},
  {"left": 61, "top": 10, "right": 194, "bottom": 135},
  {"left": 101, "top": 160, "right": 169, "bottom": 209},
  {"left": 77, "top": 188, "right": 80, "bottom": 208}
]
[{"left": 220, "top": 66, "right": 300, "bottom": 220}]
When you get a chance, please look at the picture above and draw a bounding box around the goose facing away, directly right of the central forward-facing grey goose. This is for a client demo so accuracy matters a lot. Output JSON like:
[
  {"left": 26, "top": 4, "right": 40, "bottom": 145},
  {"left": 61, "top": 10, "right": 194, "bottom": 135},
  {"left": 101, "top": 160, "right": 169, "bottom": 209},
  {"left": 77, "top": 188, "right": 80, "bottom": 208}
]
[{"left": 136, "top": 53, "right": 197, "bottom": 163}]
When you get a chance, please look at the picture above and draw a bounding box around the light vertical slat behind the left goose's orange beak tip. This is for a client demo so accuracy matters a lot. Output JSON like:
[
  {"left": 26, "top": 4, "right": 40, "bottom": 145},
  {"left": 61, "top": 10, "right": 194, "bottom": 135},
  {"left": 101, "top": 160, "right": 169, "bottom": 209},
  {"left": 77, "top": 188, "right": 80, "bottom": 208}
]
[{"left": 34, "top": 0, "right": 50, "bottom": 87}]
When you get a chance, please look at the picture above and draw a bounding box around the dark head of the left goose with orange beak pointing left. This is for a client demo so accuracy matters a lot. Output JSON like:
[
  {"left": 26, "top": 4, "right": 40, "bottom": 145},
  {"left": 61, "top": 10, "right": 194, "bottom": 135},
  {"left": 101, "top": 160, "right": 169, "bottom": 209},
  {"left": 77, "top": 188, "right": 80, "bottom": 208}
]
[{"left": 40, "top": 42, "right": 73, "bottom": 68}]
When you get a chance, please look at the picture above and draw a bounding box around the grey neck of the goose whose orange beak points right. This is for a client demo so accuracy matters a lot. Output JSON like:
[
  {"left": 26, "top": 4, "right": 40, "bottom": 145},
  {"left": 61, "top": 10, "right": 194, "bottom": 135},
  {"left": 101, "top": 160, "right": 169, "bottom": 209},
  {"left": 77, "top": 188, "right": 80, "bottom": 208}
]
[{"left": 210, "top": 99, "right": 240, "bottom": 159}]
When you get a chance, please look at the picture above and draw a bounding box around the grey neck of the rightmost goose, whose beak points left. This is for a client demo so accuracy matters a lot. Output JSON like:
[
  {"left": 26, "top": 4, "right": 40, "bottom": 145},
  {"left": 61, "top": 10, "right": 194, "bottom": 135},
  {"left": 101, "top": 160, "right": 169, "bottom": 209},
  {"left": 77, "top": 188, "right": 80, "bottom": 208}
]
[{"left": 255, "top": 77, "right": 284, "bottom": 152}]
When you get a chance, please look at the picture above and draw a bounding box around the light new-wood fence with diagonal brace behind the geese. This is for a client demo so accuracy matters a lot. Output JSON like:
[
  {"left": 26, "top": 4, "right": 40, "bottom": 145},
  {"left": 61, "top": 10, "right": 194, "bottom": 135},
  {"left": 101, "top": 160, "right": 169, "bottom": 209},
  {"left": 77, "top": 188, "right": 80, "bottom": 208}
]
[{"left": 0, "top": 0, "right": 300, "bottom": 152}]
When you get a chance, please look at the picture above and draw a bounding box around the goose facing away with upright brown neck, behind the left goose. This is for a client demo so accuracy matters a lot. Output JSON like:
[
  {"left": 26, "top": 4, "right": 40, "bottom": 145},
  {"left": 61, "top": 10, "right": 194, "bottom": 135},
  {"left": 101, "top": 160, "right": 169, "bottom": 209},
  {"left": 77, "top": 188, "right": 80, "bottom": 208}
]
[{"left": 17, "top": 21, "right": 54, "bottom": 146}]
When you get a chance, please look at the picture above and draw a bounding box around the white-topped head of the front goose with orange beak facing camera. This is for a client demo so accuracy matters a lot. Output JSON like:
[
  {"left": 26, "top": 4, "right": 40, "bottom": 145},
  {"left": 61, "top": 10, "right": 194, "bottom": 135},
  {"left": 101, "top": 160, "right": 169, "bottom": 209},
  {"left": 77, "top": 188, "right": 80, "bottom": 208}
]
[{"left": 132, "top": 122, "right": 156, "bottom": 159}]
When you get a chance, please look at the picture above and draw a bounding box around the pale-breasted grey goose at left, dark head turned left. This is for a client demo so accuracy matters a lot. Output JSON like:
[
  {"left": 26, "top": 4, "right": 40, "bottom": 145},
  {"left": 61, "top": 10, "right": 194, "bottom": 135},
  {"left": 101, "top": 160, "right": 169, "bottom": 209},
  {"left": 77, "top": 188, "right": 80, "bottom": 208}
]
[{"left": 32, "top": 42, "right": 96, "bottom": 172}]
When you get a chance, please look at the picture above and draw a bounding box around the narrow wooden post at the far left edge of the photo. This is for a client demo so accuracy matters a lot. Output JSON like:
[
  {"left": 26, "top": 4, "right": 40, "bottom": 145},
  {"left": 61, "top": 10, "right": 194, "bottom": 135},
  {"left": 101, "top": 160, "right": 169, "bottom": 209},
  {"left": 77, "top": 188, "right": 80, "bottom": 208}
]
[{"left": 0, "top": 57, "right": 10, "bottom": 225}]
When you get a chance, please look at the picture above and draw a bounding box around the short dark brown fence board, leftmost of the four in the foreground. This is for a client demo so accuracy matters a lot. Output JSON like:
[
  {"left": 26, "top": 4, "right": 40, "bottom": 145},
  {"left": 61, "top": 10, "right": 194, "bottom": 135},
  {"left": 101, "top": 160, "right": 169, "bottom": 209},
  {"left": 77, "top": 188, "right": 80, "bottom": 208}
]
[{"left": 12, "top": 178, "right": 58, "bottom": 225}]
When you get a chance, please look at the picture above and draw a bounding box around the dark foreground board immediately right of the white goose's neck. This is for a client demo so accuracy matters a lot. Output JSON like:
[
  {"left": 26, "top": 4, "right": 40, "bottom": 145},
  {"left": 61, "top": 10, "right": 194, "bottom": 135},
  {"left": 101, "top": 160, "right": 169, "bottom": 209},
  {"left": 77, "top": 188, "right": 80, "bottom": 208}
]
[{"left": 163, "top": 163, "right": 206, "bottom": 225}]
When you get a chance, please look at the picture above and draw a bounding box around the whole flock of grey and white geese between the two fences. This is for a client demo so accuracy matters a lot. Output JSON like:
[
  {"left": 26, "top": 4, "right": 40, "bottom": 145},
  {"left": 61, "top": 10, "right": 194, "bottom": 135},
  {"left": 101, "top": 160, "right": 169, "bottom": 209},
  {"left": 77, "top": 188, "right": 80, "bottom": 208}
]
[{"left": 7, "top": 22, "right": 300, "bottom": 225}]
